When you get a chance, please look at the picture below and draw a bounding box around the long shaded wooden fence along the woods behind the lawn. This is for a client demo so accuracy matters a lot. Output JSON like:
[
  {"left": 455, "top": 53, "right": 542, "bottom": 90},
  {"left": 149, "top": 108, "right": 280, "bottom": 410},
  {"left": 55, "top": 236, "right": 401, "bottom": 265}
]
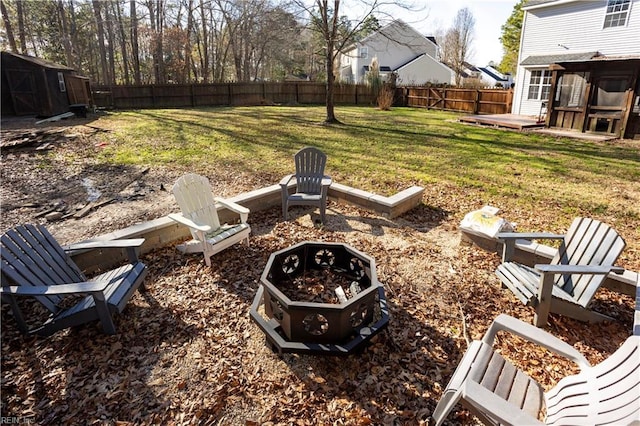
[{"left": 92, "top": 82, "right": 373, "bottom": 109}]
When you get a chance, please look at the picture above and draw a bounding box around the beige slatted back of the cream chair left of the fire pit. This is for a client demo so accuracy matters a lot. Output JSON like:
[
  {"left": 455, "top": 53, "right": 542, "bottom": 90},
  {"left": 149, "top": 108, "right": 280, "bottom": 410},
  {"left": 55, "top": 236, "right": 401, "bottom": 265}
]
[{"left": 172, "top": 173, "right": 220, "bottom": 238}]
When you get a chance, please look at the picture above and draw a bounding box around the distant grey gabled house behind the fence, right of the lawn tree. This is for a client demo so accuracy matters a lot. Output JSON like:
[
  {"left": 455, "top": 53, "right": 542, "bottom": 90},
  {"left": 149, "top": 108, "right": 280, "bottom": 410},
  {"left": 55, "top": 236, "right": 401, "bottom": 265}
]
[{"left": 338, "top": 20, "right": 455, "bottom": 85}]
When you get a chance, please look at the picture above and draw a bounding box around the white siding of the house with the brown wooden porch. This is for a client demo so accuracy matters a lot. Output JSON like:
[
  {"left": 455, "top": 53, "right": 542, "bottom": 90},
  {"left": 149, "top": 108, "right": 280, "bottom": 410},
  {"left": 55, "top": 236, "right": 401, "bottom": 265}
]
[{"left": 512, "top": 0, "right": 640, "bottom": 115}]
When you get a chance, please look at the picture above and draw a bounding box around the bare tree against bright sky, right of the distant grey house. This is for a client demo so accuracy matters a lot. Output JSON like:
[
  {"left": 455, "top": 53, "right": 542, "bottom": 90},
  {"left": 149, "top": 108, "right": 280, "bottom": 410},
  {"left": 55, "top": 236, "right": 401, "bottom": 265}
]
[{"left": 443, "top": 7, "right": 475, "bottom": 86}]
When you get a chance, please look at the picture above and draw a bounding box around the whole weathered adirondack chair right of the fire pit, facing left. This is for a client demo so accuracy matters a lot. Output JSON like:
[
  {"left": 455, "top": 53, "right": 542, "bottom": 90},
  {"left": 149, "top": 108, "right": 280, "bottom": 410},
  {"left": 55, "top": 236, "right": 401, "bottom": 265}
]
[{"left": 496, "top": 217, "right": 625, "bottom": 327}]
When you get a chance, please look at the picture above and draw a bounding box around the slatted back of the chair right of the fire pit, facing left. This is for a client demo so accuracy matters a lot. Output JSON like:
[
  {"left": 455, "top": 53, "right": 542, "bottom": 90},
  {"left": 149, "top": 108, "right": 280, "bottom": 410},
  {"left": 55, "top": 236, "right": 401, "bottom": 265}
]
[{"left": 551, "top": 217, "right": 625, "bottom": 306}]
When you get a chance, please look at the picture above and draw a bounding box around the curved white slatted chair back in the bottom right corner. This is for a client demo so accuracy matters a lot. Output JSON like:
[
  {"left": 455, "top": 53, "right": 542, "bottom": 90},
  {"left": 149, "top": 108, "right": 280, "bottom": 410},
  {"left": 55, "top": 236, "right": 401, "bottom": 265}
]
[{"left": 545, "top": 336, "right": 640, "bottom": 425}]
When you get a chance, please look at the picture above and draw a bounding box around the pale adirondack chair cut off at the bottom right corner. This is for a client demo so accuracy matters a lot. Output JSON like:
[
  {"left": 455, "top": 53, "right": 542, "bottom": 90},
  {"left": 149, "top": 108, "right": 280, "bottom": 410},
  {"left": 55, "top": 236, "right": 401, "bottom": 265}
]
[{"left": 432, "top": 314, "right": 640, "bottom": 426}]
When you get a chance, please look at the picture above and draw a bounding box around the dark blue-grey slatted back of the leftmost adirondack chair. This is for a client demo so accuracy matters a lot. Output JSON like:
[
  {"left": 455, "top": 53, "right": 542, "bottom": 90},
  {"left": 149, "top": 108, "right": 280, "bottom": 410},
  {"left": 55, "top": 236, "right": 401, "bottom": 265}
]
[{"left": 0, "top": 225, "right": 86, "bottom": 312}]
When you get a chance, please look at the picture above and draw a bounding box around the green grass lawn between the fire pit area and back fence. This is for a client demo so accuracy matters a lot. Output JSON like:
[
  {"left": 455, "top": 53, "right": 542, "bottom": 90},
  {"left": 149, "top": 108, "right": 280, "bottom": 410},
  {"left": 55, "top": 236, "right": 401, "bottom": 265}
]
[{"left": 91, "top": 106, "right": 640, "bottom": 270}]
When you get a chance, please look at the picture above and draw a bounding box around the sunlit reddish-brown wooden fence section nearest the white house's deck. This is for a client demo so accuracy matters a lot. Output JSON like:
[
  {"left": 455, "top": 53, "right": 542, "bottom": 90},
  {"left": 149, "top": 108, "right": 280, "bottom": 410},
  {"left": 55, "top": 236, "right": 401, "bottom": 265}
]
[{"left": 399, "top": 86, "right": 513, "bottom": 114}]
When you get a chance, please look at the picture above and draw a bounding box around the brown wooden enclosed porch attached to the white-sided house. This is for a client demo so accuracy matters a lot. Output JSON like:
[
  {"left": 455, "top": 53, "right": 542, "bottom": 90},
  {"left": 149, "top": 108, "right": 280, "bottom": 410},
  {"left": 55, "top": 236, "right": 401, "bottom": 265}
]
[{"left": 546, "top": 56, "right": 640, "bottom": 139}]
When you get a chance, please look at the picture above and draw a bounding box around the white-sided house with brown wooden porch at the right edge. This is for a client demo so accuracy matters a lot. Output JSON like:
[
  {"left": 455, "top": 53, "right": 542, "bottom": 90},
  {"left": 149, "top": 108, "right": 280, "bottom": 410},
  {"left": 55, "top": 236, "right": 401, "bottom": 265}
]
[{"left": 512, "top": 0, "right": 640, "bottom": 139}]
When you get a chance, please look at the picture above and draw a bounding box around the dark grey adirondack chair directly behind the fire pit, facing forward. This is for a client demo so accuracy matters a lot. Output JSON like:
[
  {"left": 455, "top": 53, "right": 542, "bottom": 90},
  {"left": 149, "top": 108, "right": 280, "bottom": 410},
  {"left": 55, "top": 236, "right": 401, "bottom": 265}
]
[{"left": 280, "top": 147, "right": 331, "bottom": 223}]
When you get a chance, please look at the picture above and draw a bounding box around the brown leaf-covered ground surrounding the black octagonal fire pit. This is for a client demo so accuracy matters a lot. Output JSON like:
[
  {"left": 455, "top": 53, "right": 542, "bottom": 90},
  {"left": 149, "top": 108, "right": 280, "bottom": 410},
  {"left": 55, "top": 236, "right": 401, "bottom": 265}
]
[{"left": 0, "top": 115, "right": 640, "bottom": 425}]
